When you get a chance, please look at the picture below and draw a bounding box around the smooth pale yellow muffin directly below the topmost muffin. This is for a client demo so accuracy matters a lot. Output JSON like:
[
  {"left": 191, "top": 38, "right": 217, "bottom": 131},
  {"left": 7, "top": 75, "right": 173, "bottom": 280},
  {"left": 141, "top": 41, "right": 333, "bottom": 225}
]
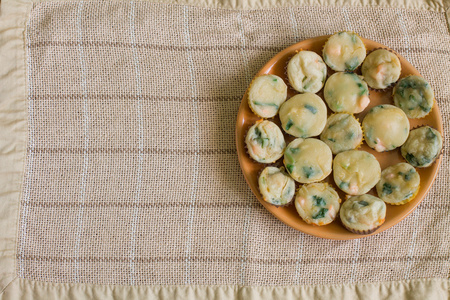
[{"left": 323, "top": 72, "right": 370, "bottom": 114}]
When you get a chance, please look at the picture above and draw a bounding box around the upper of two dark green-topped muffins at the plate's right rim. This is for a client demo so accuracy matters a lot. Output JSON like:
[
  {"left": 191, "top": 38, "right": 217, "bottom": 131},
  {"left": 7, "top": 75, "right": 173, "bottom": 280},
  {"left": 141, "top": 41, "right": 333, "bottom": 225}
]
[{"left": 392, "top": 75, "right": 434, "bottom": 119}]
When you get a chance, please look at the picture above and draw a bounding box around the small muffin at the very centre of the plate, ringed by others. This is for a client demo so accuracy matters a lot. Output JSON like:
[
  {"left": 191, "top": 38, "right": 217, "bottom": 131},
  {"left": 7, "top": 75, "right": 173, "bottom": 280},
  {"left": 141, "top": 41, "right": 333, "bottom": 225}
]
[{"left": 320, "top": 113, "right": 363, "bottom": 154}]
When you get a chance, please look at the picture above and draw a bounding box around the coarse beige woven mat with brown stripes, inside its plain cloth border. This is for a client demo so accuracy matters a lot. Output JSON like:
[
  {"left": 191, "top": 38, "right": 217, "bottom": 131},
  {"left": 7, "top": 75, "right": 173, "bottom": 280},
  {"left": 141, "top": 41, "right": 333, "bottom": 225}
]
[{"left": 0, "top": 1, "right": 450, "bottom": 296}]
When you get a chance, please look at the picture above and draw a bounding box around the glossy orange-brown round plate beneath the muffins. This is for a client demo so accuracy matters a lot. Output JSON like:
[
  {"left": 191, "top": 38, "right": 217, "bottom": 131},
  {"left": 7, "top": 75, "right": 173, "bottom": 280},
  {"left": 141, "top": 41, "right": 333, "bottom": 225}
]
[{"left": 236, "top": 36, "right": 443, "bottom": 240}]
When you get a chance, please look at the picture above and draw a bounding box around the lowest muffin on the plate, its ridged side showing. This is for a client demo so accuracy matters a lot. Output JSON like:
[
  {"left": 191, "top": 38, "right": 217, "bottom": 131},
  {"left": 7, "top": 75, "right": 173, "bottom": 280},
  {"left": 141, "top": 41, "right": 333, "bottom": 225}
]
[{"left": 339, "top": 194, "right": 386, "bottom": 234}]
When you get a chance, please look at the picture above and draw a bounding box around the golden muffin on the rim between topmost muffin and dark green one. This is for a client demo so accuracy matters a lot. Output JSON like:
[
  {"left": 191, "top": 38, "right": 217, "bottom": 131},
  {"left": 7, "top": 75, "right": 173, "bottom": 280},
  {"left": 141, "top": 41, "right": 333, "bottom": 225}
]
[{"left": 361, "top": 49, "right": 402, "bottom": 89}]
